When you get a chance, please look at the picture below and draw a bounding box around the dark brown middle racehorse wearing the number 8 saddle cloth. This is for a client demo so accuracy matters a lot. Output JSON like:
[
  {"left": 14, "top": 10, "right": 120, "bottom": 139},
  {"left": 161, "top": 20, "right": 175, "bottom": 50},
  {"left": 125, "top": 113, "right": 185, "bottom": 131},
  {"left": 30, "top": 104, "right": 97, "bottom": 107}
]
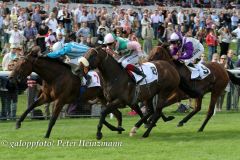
[{"left": 77, "top": 46, "right": 180, "bottom": 139}]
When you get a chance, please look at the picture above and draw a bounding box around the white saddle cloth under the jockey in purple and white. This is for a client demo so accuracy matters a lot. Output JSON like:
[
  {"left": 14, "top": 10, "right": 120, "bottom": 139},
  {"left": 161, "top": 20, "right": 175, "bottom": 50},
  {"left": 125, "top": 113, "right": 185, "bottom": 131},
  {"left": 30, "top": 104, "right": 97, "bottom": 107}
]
[{"left": 188, "top": 63, "right": 211, "bottom": 80}]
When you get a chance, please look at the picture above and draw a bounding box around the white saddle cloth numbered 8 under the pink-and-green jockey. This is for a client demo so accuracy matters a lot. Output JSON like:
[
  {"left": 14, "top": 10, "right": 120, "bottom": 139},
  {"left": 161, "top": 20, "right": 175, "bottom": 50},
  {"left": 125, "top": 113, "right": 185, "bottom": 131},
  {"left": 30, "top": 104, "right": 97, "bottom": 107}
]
[{"left": 132, "top": 62, "right": 158, "bottom": 85}]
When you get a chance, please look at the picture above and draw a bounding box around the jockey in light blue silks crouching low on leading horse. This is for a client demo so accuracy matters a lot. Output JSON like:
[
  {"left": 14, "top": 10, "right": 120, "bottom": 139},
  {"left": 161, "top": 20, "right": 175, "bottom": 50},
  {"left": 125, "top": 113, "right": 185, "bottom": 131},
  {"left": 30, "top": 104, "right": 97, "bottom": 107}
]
[{"left": 47, "top": 42, "right": 91, "bottom": 86}]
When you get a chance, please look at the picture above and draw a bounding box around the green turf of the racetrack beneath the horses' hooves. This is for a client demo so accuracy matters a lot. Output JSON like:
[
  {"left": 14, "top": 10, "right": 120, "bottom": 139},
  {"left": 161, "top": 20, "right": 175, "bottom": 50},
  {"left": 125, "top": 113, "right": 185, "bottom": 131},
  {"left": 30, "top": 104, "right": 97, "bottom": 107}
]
[{"left": 0, "top": 109, "right": 240, "bottom": 160}]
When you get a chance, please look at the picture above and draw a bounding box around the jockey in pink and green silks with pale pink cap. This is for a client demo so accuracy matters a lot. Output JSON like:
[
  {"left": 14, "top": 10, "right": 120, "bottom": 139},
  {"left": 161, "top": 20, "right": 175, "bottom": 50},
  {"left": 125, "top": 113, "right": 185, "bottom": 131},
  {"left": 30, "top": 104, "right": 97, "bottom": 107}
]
[{"left": 104, "top": 33, "right": 146, "bottom": 83}]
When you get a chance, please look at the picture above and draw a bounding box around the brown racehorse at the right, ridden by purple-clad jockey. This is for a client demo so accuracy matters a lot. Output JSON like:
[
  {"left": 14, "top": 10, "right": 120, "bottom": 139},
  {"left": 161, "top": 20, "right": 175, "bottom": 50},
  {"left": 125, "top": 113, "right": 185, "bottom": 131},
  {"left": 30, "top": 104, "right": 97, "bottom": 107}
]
[{"left": 148, "top": 44, "right": 240, "bottom": 132}]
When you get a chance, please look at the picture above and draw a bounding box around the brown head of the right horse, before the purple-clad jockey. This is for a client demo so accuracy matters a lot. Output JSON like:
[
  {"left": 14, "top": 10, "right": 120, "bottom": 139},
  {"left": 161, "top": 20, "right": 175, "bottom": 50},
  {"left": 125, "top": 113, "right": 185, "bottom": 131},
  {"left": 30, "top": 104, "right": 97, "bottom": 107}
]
[{"left": 148, "top": 43, "right": 172, "bottom": 62}]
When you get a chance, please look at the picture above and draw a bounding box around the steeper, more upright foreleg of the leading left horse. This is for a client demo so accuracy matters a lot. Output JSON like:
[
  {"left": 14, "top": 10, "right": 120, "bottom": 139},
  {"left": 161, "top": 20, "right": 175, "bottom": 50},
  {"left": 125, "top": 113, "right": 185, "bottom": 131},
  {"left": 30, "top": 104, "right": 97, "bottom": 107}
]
[{"left": 45, "top": 101, "right": 64, "bottom": 138}]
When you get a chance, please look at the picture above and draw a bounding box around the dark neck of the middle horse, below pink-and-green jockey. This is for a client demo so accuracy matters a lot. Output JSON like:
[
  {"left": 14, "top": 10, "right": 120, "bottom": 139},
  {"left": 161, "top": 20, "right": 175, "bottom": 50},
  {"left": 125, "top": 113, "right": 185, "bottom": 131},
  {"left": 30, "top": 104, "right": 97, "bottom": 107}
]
[{"left": 98, "top": 53, "right": 128, "bottom": 82}]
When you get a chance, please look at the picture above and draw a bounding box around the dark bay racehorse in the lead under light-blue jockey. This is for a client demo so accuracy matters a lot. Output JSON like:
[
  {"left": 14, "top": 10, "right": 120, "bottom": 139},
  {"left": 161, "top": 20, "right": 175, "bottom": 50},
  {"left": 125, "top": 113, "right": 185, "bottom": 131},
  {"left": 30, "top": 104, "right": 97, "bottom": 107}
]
[{"left": 9, "top": 48, "right": 143, "bottom": 138}]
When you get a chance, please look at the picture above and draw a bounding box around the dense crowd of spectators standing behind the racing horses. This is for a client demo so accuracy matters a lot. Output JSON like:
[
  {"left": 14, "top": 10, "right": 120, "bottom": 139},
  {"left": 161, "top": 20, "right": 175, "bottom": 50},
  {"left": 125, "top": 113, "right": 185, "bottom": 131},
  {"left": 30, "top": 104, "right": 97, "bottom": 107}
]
[{"left": 0, "top": 1, "right": 240, "bottom": 119}]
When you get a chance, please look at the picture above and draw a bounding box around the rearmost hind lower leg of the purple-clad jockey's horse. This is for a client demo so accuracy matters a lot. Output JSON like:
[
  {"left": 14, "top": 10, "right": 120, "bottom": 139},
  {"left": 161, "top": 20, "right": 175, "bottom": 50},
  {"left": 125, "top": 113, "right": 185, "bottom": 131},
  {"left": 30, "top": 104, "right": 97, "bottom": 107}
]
[{"left": 198, "top": 92, "right": 221, "bottom": 132}]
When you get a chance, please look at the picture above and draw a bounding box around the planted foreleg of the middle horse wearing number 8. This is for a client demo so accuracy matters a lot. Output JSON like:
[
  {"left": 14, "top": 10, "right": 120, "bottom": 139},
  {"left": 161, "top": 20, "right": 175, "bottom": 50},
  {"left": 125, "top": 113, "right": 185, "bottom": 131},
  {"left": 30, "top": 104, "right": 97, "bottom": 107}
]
[{"left": 96, "top": 99, "right": 121, "bottom": 140}]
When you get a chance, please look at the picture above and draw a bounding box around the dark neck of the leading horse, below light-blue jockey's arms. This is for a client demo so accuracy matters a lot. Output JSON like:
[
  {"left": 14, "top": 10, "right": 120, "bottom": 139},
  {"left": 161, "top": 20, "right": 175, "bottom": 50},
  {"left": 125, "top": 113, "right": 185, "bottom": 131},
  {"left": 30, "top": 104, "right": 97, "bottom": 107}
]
[{"left": 33, "top": 59, "right": 64, "bottom": 83}]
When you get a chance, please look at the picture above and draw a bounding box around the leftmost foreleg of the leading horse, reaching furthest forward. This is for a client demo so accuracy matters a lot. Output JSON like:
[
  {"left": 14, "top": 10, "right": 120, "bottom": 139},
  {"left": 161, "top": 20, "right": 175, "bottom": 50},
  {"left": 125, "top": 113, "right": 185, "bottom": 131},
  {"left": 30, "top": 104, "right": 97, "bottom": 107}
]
[{"left": 16, "top": 94, "right": 46, "bottom": 129}]
